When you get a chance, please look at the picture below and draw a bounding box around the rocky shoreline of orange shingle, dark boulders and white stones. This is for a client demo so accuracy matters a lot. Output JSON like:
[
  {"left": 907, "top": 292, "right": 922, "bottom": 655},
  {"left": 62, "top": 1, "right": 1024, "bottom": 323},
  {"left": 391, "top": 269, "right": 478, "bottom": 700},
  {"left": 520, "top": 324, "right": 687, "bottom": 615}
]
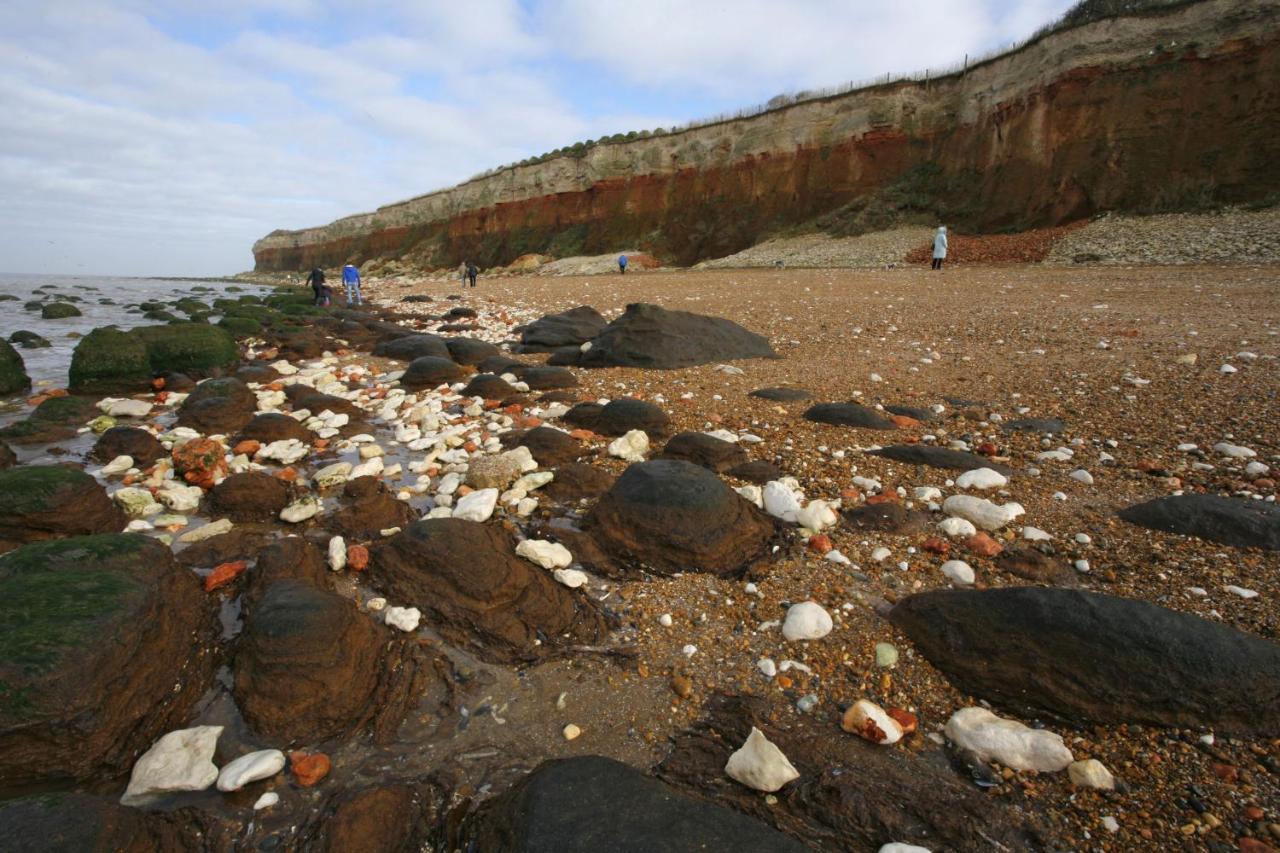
[{"left": 0, "top": 262, "right": 1280, "bottom": 850}]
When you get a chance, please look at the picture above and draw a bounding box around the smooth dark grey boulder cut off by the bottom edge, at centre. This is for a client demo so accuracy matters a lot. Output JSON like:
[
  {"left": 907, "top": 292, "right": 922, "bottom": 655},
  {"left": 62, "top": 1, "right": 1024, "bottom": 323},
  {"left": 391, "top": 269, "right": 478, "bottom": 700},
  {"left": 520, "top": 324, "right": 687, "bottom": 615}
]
[{"left": 451, "top": 756, "right": 808, "bottom": 853}]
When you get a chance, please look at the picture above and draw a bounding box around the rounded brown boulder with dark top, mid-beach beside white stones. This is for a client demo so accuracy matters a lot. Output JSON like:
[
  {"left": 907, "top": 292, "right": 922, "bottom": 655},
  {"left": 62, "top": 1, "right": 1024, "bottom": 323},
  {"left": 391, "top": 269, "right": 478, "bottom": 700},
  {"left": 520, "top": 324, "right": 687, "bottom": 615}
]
[{"left": 590, "top": 460, "right": 773, "bottom": 575}]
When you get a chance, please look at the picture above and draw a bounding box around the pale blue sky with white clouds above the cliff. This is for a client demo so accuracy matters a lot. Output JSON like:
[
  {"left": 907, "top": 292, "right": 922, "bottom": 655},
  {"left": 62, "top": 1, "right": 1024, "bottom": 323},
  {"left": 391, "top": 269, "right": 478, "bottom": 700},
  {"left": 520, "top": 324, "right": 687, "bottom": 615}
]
[{"left": 0, "top": 0, "right": 1073, "bottom": 275}]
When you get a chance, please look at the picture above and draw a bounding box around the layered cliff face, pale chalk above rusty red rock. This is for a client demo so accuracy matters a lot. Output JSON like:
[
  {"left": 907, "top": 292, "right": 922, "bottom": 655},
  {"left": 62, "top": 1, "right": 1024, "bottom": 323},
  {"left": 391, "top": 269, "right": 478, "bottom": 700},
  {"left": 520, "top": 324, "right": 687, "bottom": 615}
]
[{"left": 253, "top": 0, "right": 1280, "bottom": 270}]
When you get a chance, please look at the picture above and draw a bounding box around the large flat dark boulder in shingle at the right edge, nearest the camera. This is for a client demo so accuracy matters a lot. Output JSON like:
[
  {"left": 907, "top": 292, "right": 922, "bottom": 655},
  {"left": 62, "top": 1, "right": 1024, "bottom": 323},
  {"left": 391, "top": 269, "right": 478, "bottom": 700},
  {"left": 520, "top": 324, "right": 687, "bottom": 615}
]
[{"left": 890, "top": 587, "right": 1280, "bottom": 736}]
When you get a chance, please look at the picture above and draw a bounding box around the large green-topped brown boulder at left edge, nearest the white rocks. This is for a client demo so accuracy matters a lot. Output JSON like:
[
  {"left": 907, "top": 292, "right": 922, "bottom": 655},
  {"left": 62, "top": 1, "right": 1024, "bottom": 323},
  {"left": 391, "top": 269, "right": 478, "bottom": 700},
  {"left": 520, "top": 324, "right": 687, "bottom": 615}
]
[{"left": 0, "top": 535, "right": 215, "bottom": 786}]
